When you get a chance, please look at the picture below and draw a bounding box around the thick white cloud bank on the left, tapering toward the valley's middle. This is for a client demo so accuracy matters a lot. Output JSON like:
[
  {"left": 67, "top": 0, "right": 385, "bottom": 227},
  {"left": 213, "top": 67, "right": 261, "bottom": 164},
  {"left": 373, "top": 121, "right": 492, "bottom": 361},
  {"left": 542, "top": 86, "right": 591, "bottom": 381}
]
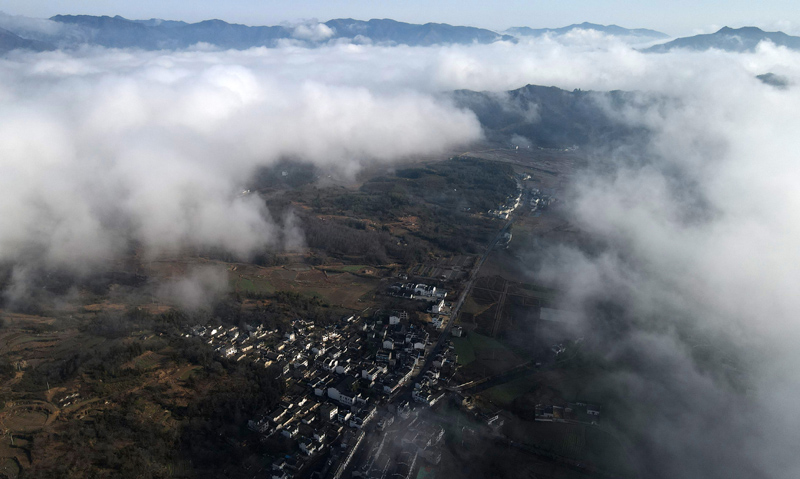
[{"left": 0, "top": 46, "right": 481, "bottom": 266}]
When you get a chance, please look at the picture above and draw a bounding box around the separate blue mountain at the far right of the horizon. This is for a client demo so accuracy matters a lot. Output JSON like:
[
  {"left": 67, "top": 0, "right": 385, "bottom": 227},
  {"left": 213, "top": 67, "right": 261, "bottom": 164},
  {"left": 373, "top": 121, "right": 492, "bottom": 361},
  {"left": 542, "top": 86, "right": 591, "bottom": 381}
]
[{"left": 643, "top": 27, "right": 800, "bottom": 53}]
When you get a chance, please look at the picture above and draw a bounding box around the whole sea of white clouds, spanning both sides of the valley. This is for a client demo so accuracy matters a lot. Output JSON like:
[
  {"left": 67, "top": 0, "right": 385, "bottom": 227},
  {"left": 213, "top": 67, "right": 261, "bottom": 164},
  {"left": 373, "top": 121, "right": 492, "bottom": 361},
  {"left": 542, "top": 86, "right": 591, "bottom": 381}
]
[{"left": 0, "top": 17, "right": 800, "bottom": 479}]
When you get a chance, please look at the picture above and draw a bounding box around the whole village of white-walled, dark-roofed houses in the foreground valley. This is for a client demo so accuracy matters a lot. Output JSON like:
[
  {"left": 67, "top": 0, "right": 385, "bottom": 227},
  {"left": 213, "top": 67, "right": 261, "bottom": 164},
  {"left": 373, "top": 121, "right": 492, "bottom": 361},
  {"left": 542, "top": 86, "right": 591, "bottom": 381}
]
[{"left": 178, "top": 285, "right": 460, "bottom": 479}]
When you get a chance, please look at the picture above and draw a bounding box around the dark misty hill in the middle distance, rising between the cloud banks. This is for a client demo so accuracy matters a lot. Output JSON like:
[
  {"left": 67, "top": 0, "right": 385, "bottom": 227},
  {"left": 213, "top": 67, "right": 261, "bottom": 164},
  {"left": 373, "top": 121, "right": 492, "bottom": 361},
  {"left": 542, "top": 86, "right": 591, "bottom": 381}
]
[{"left": 452, "top": 85, "right": 642, "bottom": 148}]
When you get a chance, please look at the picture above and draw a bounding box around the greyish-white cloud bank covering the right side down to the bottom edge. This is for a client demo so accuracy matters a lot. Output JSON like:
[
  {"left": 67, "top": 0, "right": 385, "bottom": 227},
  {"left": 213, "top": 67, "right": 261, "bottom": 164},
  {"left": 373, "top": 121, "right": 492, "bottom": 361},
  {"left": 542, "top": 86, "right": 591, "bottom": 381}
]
[{"left": 520, "top": 38, "right": 800, "bottom": 478}]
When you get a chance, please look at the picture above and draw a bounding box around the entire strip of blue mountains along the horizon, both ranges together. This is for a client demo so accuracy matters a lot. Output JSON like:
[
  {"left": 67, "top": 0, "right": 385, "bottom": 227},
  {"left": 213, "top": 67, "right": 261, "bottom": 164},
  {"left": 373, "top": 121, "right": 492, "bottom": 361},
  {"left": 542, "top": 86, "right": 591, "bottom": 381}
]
[{"left": 0, "top": 14, "right": 800, "bottom": 53}]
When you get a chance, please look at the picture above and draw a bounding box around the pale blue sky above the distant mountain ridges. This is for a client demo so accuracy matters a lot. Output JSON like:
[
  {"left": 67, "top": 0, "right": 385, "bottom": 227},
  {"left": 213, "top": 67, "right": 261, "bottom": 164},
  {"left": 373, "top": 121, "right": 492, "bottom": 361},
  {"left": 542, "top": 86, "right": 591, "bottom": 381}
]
[{"left": 0, "top": 0, "right": 800, "bottom": 35}]
